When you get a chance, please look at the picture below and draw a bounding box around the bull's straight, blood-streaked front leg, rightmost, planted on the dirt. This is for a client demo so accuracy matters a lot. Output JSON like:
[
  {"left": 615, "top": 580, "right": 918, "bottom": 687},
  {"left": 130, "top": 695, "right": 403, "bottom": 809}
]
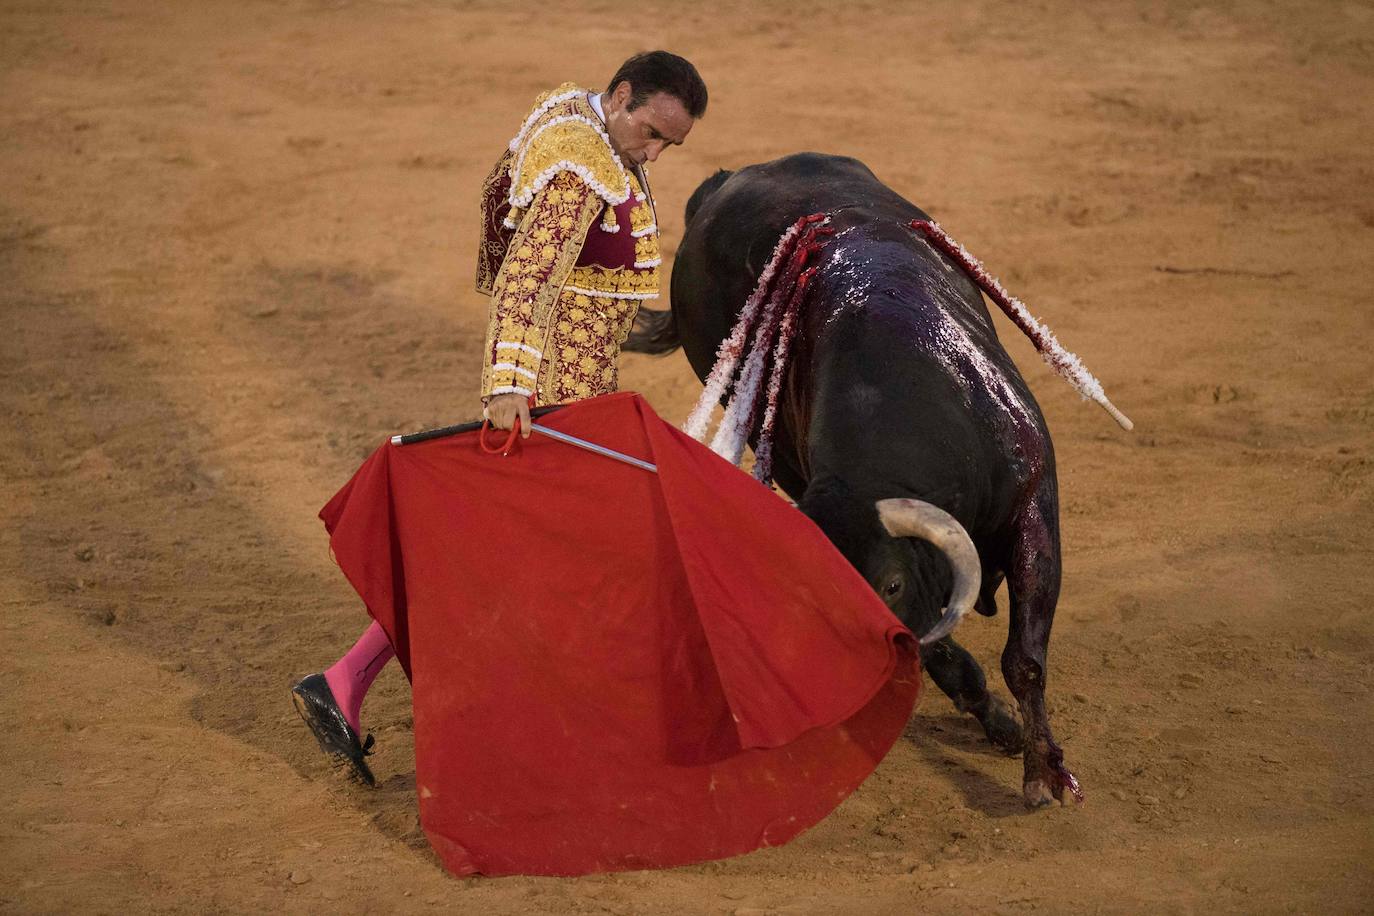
[{"left": 1002, "top": 489, "right": 1083, "bottom": 808}]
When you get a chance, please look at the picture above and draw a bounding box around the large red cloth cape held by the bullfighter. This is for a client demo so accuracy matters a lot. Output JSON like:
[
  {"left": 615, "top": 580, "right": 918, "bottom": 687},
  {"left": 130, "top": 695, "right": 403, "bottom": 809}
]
[{"left": 320, "top": 391, "right": 921, "bottom": 875}]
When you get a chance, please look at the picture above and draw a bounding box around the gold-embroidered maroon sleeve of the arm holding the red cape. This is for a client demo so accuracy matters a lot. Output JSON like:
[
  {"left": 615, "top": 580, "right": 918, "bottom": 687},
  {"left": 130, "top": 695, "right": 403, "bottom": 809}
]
[{"left": 482, "top": 172, "right": 602, "bottom": 400}]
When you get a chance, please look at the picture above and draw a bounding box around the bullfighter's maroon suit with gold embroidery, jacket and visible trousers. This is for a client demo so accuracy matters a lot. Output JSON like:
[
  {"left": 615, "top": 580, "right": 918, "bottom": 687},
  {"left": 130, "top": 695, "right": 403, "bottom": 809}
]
[{"left": 477, "top": 82, "right": 660, "bottom": 404}]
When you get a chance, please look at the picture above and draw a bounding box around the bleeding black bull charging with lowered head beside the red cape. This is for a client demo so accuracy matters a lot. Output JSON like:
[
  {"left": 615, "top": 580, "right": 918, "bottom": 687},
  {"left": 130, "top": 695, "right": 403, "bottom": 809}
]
[{"left": 627, "top": 152, "right": 1081, "bottom": 806}]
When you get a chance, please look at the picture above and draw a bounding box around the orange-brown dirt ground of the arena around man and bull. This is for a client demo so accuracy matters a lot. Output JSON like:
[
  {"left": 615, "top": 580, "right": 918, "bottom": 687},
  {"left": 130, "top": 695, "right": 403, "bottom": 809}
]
[{"left": 0, "top": 0, "right": 1374, "bottom": 916}]
